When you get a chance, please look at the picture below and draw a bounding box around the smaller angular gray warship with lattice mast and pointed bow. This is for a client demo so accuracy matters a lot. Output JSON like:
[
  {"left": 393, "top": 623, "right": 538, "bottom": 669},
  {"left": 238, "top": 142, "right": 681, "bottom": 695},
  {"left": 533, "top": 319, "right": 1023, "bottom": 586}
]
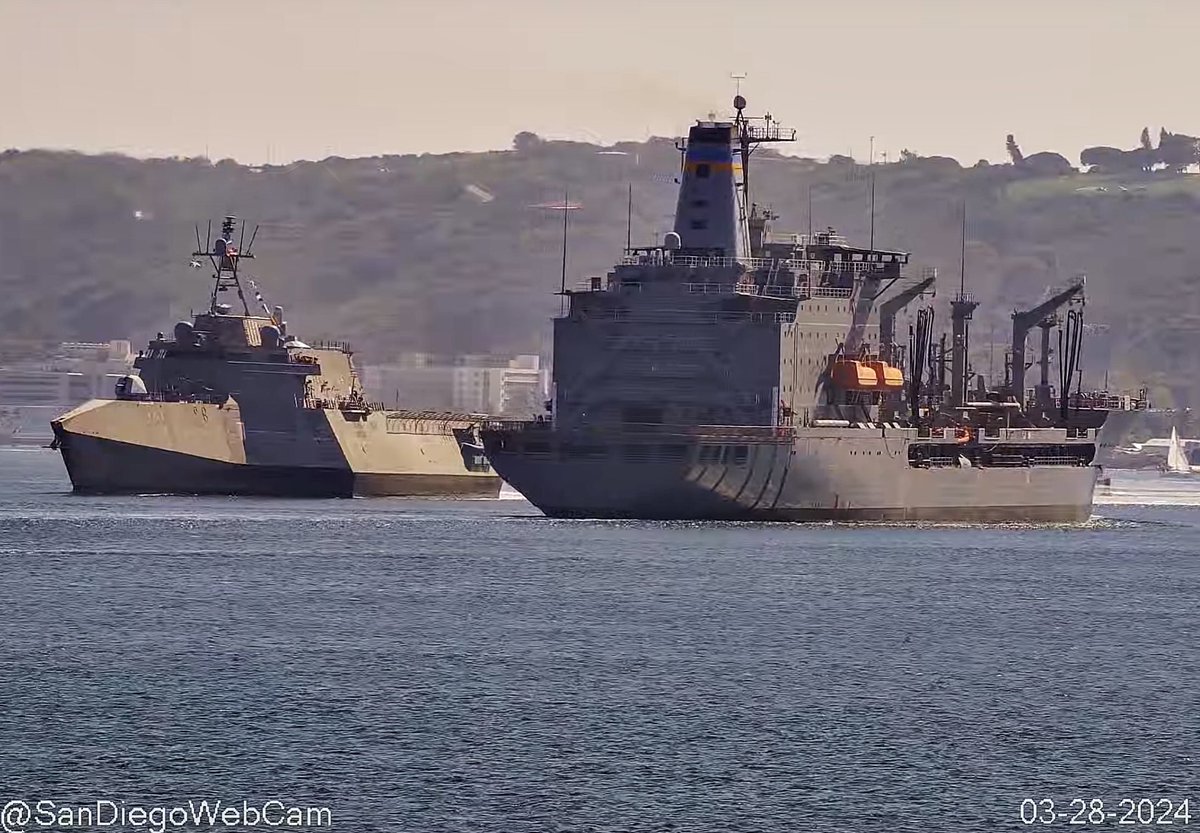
[{"left": 52, "top": 217, "right": 500, "bottom": 497}]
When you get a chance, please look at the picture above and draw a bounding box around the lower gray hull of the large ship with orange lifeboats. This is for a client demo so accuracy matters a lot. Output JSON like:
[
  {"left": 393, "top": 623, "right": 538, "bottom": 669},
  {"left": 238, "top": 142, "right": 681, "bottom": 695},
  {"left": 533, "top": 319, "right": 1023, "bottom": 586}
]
[{"left": 484, "top": 431, "right": 1098, "bottom": 523}]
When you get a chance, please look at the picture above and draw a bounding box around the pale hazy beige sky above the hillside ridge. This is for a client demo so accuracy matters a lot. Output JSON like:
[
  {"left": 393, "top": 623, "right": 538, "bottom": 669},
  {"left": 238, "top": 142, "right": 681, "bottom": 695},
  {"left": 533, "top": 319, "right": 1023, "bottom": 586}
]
[{"left": 0, "top": 0, "right": 1200, "bottom": 163}]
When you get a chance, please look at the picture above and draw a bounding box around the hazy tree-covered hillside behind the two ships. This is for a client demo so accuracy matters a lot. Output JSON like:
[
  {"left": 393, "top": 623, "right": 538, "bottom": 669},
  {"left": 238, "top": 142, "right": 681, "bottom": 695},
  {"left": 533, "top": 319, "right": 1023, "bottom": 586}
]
[{"left": 0, "top": 134, "right": 1200, "bottom": 404}]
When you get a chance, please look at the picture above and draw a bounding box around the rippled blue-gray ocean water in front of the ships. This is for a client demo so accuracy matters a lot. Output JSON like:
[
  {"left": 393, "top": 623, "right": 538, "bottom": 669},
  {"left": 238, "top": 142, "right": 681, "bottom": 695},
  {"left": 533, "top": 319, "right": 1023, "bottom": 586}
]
[{"left": 0, "top": 450, "right": 1200, "bottom": 833}]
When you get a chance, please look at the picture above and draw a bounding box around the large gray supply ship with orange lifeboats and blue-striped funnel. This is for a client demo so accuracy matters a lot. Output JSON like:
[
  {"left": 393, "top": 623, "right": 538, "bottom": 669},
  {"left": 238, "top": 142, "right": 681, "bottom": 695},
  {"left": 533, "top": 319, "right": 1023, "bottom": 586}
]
[{"left": 482, "top": 96, "right": 1123, "bottom": 522}]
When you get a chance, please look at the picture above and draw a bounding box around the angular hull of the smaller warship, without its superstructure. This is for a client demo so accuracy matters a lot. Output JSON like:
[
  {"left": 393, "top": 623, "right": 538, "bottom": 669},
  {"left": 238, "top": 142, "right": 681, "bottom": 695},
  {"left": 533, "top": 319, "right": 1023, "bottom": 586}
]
[{"left": 52, "top": 401, "right": 502, "bottom": 498}]
